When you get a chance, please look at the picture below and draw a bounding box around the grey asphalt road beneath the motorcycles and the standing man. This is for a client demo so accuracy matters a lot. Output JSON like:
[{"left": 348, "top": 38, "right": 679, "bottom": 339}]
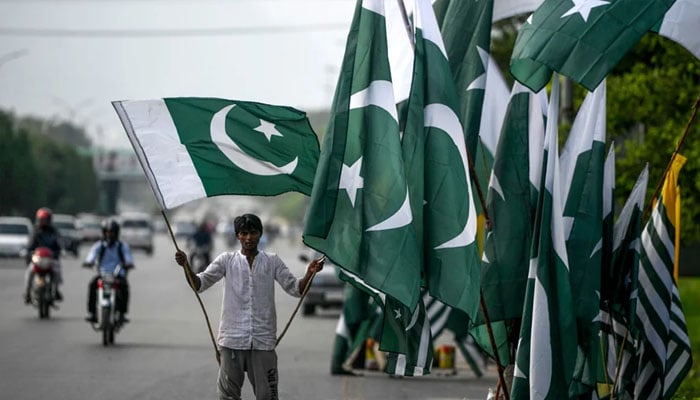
[{"left": 0, "top": 234, "right": 496, "bottom": 400}]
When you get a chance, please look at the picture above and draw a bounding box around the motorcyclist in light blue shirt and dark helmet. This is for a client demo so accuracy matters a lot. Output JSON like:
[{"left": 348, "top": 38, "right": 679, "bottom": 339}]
[{"left": 83, "top": 218, "right": 134, "bottom": 323}]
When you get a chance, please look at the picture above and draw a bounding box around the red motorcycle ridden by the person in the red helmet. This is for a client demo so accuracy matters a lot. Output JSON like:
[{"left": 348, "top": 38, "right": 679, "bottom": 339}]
[{"left": 30, "top": 247, "right": 58, "bottom": 319}]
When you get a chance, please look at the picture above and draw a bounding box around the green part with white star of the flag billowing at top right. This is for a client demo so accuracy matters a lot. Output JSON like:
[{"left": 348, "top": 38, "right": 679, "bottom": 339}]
[{"left": 510, "top": 0, "right": 675, "bottom": 91}]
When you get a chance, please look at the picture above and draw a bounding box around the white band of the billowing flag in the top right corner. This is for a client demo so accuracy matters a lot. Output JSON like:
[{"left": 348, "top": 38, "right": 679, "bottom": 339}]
[{"left": 653, "top": 0, "right": 700, "bottom": 58}]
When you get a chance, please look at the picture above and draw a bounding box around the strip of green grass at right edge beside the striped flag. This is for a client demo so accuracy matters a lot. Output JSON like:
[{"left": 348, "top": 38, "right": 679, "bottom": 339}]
[{"left": 673, "top": 277, "right": 700, "bottom": 400}]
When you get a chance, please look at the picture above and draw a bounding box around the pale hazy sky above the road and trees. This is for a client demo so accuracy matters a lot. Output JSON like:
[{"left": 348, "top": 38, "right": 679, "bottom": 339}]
[{"left": 0, "top": 0, "right": 355, "bottom": 148}]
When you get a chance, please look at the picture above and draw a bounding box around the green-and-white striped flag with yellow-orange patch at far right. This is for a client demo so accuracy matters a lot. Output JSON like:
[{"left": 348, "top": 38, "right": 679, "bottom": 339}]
[{"left": 634, "top": 154, "right": 693, "bottom": 399}]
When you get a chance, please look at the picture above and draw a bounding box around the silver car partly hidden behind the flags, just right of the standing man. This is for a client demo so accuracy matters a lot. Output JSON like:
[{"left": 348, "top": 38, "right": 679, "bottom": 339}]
[{"left": 299, "top": 253, "right": 345, "bottom": 316}]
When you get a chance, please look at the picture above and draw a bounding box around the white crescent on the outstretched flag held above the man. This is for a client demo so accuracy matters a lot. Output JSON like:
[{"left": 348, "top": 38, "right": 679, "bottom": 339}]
[{"left": 210, "top": 104, "right": 299, "bottom": 176}]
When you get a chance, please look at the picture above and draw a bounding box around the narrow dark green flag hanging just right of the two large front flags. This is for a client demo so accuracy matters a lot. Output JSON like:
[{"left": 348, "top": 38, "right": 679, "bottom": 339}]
[{"left": 472, "top": 82, "right": 547, "bottom": 366}]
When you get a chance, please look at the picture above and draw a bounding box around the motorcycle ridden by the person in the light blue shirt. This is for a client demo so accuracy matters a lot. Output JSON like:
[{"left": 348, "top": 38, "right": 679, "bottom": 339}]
[{"left": 92, "top": 264, "right": 124, "bottom": 346}]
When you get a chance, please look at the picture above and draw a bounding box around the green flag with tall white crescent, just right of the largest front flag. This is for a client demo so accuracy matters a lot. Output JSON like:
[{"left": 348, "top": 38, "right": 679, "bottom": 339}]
[{"left": 402, "top": 0, "right": 480, "bottom": 318}]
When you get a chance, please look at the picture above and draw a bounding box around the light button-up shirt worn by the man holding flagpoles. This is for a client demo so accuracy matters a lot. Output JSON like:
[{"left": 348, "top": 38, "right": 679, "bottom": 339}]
[{"left": 197, "top": 250, "right": 301, "bottom": 350}]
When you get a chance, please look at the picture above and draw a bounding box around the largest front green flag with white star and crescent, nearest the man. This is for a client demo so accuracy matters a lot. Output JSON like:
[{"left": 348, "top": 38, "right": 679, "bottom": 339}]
[{"left": 303, "top": 0, "right": 422, "bottom": 310}]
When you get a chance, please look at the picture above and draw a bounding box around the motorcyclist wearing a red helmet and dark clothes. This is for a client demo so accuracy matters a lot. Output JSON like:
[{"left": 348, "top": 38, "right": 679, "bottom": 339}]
[{"left": 24, "top": 207, "right": 63, "bottom": 303}]
